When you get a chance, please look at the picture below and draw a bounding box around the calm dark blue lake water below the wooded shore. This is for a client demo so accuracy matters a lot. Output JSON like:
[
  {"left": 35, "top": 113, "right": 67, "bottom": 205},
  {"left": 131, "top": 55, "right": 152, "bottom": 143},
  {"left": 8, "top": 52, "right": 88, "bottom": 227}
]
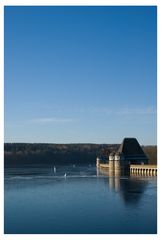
[{"left": 4, "top": 165, "right": 157, "bottom": 234}]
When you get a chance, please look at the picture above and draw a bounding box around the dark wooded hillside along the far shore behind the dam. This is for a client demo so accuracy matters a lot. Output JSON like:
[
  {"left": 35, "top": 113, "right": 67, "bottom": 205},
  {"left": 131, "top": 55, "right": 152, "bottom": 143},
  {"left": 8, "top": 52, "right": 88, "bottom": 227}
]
[{"left": 4, "top": 143, "right": 157, "bottom": 165}]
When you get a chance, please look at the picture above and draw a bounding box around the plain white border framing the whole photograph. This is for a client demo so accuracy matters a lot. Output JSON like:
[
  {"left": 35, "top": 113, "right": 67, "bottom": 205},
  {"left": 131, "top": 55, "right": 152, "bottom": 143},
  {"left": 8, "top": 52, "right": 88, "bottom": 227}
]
[{"left": 0, "top": 0, "right": 161, "bottom": 240}]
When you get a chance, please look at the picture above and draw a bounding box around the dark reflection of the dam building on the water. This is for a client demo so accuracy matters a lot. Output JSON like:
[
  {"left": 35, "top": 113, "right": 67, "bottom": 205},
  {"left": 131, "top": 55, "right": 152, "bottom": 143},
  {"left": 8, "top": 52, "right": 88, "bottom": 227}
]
[{"left": 97, "top": 169, "right": 149, "bottom": 205}]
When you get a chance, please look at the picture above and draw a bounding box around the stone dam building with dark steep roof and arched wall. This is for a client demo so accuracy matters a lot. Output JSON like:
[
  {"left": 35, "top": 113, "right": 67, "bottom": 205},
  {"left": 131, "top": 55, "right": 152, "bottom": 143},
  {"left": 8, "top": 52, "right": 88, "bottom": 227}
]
[{"left": 96, "top": 138, "right": 157, "bottom": 176}]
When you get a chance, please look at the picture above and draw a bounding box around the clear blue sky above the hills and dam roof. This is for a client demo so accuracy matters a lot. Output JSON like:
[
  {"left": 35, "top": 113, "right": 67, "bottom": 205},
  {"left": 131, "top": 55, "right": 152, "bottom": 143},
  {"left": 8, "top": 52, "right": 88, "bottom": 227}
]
[{"left": 5, "top": 6, "right": 157, "bottom": 145}]
